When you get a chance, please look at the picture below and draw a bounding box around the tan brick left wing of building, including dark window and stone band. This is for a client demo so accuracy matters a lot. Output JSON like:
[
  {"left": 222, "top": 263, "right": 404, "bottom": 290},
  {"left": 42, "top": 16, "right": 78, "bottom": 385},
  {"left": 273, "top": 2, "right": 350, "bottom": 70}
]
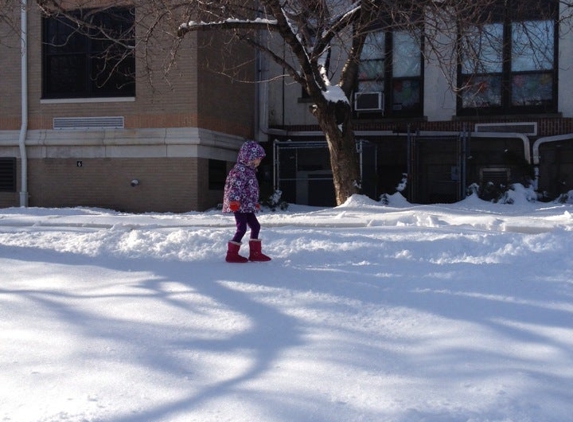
[{"left": 0, "top": 7, "right": 255, "bottom": 212}]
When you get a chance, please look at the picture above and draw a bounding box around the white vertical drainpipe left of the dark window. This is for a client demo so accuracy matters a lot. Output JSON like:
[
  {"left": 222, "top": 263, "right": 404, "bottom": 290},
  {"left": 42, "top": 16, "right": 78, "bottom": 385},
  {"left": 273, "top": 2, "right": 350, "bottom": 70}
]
[{"left": 18, "top": 0, "right": 28, "bottom": 207}]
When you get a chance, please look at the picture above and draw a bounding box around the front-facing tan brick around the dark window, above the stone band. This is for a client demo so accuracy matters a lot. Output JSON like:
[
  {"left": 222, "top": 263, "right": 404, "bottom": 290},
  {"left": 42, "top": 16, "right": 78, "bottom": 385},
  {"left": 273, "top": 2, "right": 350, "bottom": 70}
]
[{"left": 16, "top": 9, "right": 203, "bottom": 130}]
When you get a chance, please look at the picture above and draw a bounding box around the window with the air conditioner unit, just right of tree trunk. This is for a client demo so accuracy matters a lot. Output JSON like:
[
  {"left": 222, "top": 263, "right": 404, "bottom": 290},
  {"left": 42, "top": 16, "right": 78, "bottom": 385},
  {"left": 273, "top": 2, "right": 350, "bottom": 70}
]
[{"left": 355, "top": 31, "right": 423, "bottom": 116}]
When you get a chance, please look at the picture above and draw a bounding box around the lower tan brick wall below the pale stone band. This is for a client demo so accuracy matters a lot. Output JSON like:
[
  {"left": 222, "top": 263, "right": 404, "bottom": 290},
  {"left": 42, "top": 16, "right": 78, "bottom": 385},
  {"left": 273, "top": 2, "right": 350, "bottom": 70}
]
[{"left": 28, "top": 158, "right": 226, "bottom": 212}]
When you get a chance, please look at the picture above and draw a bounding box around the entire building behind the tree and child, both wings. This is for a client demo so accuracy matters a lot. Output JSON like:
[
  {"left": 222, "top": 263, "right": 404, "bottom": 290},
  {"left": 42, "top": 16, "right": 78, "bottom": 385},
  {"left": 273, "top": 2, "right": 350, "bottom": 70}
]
[{"left": 0, "top": 0, "right": 573, "bottom": 212}]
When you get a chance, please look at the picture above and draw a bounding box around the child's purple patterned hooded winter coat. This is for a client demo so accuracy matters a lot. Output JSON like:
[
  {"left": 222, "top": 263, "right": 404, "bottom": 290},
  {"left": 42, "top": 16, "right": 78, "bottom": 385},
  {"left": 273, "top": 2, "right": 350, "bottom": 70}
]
[{"left": 223, "top": 141, "right": 266, "bottom": 212}]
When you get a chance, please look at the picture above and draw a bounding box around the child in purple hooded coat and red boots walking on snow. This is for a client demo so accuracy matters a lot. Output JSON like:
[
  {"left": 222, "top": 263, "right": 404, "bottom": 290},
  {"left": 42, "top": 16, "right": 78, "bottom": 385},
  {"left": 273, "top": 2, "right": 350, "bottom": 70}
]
[{"left": 223, "top": 141, "right": 271, "bottom": 262}]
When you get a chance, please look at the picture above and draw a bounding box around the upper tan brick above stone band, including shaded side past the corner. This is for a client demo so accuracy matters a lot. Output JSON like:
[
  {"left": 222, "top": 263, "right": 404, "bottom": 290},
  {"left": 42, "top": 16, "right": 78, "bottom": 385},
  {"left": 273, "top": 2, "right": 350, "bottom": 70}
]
[{"left": 0, "top": 7, "right": 255, "bottom": 137}]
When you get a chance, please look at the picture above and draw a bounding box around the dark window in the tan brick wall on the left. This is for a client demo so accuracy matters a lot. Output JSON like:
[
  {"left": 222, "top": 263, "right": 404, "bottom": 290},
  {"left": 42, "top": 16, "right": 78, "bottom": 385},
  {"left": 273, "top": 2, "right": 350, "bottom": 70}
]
[{"left": 42, "top": 8, "right": 135, "bottom": 98}]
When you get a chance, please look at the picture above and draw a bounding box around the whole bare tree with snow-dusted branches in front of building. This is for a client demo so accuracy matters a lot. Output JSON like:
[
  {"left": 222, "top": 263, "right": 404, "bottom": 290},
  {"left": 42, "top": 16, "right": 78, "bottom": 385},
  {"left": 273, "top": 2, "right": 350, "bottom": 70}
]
[{"left": 179, "top": 0, "right": 512, "bottom": 204}]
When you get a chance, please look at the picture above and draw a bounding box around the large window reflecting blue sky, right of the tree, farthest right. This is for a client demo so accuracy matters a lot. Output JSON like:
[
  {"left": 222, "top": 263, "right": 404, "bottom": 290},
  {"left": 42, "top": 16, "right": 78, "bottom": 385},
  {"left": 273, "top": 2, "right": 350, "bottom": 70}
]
[{"left": 458, "top": 0, "right": 558, "bottom": 114}]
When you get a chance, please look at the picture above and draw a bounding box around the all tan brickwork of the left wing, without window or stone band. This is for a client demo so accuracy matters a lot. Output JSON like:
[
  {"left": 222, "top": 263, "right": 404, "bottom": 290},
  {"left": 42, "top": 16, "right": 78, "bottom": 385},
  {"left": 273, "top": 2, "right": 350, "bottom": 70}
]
[{"left": 0, "top": 6, "right": 255, "bottom": 212}]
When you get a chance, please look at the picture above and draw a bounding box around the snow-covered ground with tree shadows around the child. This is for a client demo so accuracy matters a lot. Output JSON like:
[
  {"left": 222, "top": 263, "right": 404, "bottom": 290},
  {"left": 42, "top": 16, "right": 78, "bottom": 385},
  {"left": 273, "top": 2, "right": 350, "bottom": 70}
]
[{"left": 0, "top": 194, "right": 573, "bottom": 422}]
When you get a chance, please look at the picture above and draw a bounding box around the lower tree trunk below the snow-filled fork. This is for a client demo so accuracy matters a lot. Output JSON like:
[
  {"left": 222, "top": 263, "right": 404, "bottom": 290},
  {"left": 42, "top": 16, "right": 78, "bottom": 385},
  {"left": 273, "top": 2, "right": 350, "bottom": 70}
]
[{"left": 313, "top": 101, "right": 361, "bottom": 205}]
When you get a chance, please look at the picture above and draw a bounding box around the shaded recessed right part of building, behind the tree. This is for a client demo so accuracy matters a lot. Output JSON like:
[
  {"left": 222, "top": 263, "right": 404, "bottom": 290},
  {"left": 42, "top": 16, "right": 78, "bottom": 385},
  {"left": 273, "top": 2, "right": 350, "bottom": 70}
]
[{"left": 266, "top": 0, "right": 573, "bottom": 205}]
